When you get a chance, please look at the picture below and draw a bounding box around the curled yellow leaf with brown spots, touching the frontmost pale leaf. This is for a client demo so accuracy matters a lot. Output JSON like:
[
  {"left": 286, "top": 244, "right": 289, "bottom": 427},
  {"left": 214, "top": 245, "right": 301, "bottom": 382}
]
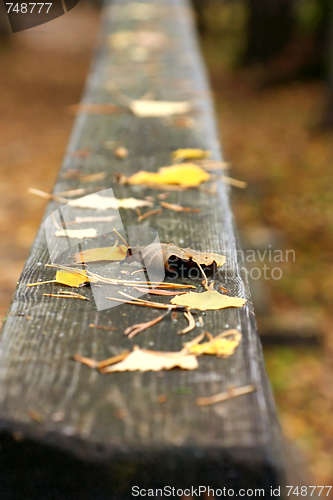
[{"left": 185, "top": 330, "right": 242, "bottom": 357}]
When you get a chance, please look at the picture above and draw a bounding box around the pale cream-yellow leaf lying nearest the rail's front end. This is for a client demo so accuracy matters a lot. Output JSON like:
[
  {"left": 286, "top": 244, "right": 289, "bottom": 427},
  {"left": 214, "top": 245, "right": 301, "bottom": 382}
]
[{"left": 104, "top": 348, "right": 199, "bottom": 373}]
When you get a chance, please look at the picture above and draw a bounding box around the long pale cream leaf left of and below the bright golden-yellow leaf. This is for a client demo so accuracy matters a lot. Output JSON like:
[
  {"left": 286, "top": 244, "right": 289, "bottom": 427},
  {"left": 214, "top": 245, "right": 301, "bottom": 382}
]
[{"left": 66, "top": 193, "right": 152, "bottom": 210}]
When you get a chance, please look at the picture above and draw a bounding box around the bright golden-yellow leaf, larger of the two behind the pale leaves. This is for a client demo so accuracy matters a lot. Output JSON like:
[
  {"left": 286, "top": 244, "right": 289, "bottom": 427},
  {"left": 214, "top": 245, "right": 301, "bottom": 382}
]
[{"left": 127, "top": 163, "right": 210, "bottom": 187}]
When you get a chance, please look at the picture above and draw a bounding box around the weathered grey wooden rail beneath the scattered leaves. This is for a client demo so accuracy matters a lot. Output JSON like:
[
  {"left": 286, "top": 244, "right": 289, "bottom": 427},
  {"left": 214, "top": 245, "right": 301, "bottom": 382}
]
[{"left": 0, "top": 0, "right": 283, "bottom": 495}]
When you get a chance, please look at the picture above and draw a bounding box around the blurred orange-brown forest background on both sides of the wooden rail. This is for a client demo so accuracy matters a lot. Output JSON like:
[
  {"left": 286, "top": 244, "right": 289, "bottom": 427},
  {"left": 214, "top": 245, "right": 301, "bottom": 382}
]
[{"left": 0, "top": 0, "right": 333, "bottom": 485}]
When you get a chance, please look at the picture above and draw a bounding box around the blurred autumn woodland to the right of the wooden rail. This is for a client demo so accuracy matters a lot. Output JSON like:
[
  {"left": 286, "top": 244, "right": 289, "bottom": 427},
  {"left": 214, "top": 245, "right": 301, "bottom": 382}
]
[{"left": 198, "top": 0, "right": 333, "bottom": 484}]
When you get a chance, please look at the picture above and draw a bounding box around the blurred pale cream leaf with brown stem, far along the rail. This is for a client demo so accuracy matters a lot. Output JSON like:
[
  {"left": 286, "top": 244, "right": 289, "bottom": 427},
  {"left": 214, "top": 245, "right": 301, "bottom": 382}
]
[{"left": 106, "top": 81, "right": 192, "bottom": 118}]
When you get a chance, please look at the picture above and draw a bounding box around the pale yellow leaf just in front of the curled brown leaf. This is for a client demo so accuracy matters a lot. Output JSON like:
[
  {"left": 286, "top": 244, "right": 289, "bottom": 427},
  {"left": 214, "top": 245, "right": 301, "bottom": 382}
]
[{"left": 170, "top": 290, "right": 246, "bottom": 311}]
